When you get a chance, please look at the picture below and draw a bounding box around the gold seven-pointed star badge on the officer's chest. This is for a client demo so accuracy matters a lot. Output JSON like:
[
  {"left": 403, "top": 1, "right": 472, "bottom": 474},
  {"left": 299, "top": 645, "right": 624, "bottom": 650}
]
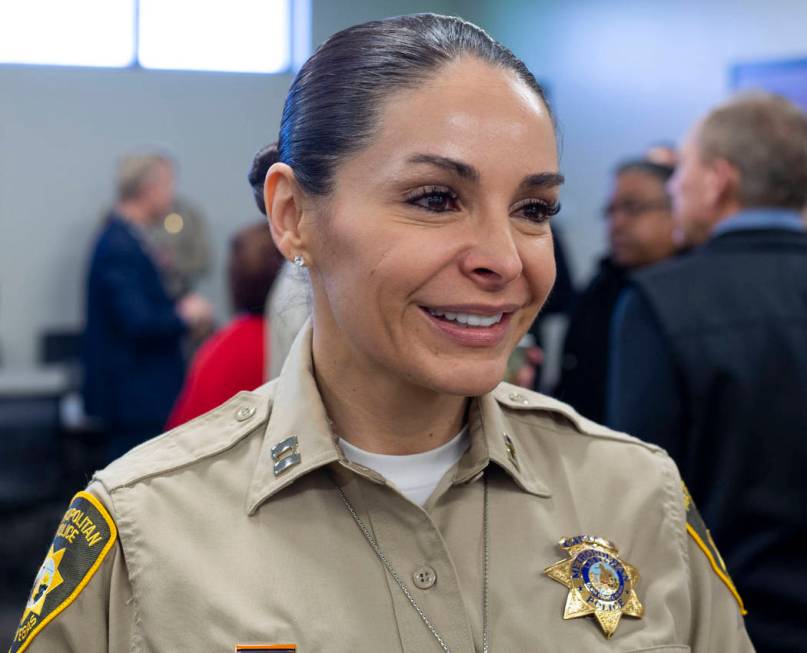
[{"left": 544, "top": 535, "right": 644, "bottom": 639}]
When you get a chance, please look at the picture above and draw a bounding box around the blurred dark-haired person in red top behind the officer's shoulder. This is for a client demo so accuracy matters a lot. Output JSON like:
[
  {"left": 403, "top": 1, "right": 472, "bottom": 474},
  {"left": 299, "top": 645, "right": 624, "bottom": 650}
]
[{"left": 166, "top": 222, "right": 283, "bottom": 429}]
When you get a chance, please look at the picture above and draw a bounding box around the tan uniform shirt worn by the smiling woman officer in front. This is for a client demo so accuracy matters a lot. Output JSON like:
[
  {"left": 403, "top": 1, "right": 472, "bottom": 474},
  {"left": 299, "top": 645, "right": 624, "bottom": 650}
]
[{"left": 15, "top": 332, "right": 753, "bottom": 653}]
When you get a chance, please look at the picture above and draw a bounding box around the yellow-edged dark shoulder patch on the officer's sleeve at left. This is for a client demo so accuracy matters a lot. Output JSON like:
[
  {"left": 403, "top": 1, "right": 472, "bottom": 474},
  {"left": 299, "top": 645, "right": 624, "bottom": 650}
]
[{"left": 9, "top": 492, "right": 118, "bottom": 653}]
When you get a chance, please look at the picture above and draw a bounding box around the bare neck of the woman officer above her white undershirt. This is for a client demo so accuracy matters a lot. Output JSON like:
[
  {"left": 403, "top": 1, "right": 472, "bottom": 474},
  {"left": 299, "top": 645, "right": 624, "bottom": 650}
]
[{"left": 313, "top": 320, "right": 468, "bottom": 455}]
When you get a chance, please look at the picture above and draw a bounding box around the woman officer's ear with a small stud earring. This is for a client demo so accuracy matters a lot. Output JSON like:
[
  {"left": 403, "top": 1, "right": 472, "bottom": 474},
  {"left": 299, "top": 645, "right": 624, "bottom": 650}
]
[{"left": 263, "top": 163, "right": 307, "bottom": 261}]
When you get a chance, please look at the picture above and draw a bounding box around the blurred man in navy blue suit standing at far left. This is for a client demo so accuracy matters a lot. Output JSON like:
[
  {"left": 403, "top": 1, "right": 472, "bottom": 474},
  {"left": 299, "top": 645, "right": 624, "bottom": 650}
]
[{"left": 82, "top": 155, "right": 212, "bottom": 459}]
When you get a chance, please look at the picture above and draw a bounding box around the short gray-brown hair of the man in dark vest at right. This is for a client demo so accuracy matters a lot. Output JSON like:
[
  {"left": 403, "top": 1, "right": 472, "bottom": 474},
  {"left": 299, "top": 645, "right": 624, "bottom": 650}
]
[{"left": 697, "top": 91, "right": 807, "bottom": 210}]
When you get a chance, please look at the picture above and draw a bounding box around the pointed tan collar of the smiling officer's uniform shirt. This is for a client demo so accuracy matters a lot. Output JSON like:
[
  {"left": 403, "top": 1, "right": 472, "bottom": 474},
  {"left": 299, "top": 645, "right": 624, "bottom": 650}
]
[{"left": 246, "top": 320, "right": 549, "bottom": 514}]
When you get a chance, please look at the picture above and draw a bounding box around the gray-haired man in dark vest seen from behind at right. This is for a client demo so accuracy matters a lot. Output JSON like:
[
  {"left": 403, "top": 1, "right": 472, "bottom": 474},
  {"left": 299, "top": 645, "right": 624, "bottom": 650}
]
[{"left": 609, "top": 93, "right": 807, "bottom": 653}]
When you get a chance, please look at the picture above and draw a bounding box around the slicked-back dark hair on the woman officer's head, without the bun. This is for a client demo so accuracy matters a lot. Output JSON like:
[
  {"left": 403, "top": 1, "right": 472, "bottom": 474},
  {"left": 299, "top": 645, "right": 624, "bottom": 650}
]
[{"left": 274, "top": 14, "right": 548, "bottom": 196}]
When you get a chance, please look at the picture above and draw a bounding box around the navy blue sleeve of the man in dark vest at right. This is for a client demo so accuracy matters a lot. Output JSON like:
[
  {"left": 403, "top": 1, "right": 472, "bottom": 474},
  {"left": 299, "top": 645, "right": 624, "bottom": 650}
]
[{"left": 606, "top": 289, "right": 686, "bottom": 464}]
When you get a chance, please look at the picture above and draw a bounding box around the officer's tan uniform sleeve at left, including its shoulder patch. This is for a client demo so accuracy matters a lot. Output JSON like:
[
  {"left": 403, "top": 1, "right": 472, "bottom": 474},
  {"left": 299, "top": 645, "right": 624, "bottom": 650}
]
[{"left": 9, "top": 492, "right": 134, "bottom": 653}]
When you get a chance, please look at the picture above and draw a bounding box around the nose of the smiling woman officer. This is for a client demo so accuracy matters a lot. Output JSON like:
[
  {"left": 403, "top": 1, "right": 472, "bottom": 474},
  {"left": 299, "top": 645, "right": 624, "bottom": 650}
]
[{"left": 462, "top": 216, "right": 524, "bottom": 290}]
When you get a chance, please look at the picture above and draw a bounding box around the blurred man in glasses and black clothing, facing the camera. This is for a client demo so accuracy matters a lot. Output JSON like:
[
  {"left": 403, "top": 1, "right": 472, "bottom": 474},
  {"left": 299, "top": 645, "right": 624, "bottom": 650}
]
[{"left": 554, "top": 159, "right": 676, "bottom": 422}]
